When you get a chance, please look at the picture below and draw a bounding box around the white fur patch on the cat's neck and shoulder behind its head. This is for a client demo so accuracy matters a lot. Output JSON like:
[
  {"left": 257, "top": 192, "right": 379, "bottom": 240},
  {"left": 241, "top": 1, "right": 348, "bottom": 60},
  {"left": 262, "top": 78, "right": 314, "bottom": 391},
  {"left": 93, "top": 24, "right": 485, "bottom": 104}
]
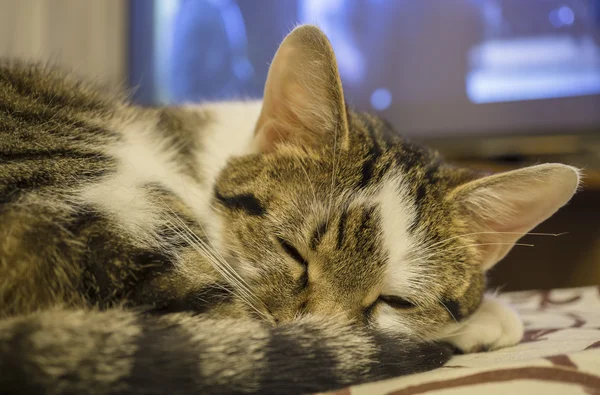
[{"left": 79, "top": 101, "right": 261, "bottom": 252}]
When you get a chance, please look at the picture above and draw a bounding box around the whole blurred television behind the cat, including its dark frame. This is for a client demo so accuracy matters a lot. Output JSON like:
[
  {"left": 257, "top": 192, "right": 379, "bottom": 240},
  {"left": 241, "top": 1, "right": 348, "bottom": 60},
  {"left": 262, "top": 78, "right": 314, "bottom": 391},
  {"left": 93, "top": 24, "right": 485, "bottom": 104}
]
[{"left": 130, "top": 0, "right": 600, "bottom": 136}]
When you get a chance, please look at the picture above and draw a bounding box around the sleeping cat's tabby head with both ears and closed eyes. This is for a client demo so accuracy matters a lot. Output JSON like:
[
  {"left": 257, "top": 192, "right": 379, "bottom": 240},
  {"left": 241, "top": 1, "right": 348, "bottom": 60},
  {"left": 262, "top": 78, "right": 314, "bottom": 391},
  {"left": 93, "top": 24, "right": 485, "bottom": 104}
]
[{"left": 214, "top": 26, "right": 579, "bottom": 336}]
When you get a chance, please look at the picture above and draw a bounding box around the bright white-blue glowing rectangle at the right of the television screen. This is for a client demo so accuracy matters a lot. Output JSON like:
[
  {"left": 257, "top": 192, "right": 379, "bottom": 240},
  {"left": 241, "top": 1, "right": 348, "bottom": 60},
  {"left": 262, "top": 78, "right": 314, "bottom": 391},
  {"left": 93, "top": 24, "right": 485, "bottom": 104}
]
[{"left": 466, "top": 35, "right": 600, "bottom": 104}]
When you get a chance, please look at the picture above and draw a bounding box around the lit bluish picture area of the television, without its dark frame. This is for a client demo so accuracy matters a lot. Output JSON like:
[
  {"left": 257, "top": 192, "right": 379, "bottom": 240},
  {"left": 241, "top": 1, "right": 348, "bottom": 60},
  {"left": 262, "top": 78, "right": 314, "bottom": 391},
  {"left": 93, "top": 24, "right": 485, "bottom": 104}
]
[{"left": 155, "top": 0, "right": 600, "bottom": 111}]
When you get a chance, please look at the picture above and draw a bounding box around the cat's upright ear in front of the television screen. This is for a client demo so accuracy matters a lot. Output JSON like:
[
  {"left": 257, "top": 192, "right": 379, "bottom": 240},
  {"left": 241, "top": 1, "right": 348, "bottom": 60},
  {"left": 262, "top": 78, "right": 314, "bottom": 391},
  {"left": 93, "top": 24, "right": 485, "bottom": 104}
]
[{"left": 255, "top": 25, "right": 348, "bottom": 152}]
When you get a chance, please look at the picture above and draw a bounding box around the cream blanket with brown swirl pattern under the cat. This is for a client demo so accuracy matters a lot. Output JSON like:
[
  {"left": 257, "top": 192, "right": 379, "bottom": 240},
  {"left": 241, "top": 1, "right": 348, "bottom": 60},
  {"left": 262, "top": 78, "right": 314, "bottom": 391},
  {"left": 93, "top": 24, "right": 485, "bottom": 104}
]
[{"left": 329, "top": 287, "right": 600, "bottom": 395}]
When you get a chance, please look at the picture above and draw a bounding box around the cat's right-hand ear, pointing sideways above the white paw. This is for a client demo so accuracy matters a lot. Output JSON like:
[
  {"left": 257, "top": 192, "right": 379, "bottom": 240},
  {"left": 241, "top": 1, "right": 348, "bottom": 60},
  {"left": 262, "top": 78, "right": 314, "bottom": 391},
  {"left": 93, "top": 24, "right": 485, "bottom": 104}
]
[{"left": 450, "top": 164, "right": 579, "bottom": 270}]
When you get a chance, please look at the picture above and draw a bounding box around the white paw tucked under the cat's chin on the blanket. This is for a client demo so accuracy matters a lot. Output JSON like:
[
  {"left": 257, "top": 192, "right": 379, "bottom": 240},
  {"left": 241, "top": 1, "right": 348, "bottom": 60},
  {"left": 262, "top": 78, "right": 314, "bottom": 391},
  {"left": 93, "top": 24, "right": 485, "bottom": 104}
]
[{"left": 444, "top": 296, "right": 523, "bottom": 353}]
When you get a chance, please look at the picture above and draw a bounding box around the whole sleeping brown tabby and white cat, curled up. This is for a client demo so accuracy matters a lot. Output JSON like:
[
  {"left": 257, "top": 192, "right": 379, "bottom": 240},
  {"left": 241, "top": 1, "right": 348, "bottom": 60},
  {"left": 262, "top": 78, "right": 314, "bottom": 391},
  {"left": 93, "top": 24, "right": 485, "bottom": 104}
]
[{"left": 0, "top": 26, "right": 579, "bottom": 394}]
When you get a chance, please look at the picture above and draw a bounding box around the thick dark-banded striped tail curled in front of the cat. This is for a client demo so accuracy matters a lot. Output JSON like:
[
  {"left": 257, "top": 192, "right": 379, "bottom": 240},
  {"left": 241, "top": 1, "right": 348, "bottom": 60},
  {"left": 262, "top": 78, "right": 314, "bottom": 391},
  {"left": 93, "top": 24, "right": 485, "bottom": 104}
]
[{"left": 0, "top": 309, "right": 449, "bottom": 394}]
